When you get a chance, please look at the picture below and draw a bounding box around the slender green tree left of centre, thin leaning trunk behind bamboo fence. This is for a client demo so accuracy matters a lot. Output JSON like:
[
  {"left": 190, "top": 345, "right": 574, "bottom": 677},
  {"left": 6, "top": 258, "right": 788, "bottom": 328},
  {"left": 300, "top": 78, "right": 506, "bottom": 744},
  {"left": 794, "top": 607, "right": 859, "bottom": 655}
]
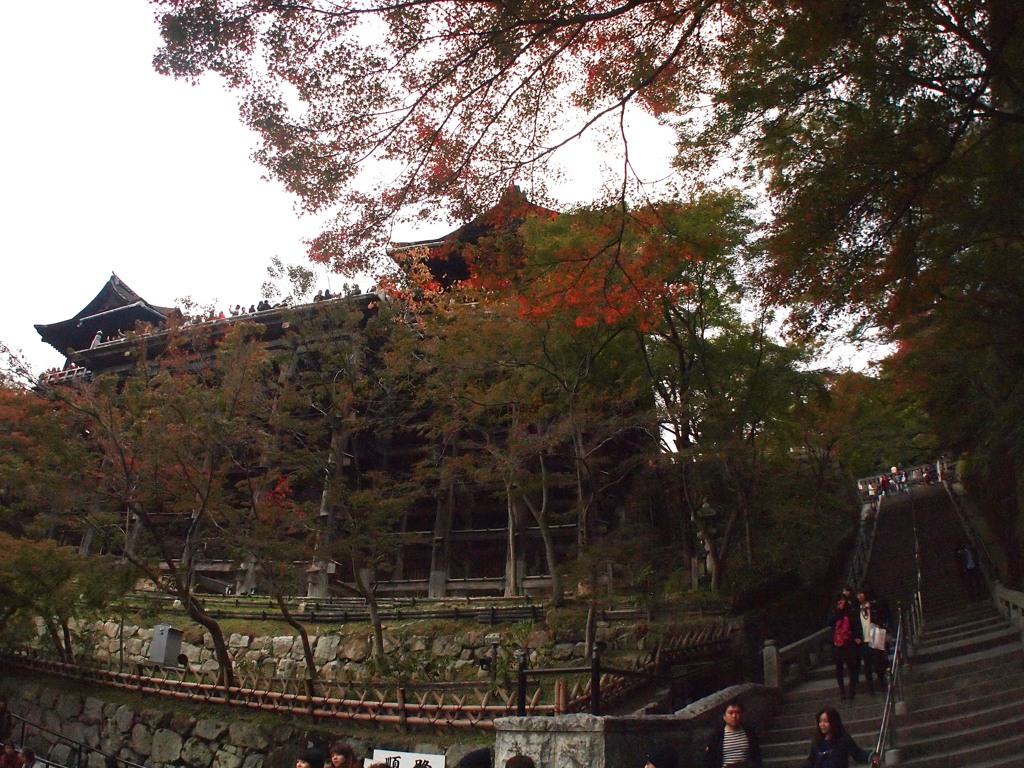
[{"left": 279, "top": 300, "right": 418, "bottom": 662}]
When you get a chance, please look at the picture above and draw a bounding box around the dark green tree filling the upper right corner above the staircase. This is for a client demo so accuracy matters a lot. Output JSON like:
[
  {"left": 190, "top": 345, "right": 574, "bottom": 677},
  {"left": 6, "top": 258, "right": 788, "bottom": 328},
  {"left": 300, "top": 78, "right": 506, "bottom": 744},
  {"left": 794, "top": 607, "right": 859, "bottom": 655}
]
[{"left": 684, "top": 0, "right": 1024, "bottom": 581}]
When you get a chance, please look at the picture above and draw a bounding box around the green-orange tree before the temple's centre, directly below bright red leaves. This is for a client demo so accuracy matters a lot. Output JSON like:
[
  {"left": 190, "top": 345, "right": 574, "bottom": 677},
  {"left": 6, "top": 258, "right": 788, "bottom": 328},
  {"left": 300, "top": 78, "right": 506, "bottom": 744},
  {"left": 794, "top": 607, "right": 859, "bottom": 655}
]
[{"left": 407, "top": 289, "right": 647, "bottom": 604}]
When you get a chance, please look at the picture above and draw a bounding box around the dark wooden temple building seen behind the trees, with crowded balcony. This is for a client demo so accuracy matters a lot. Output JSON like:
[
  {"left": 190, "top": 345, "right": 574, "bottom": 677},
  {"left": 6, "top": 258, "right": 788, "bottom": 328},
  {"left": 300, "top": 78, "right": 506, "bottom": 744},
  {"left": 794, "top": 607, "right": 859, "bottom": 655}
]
[{"left": 36, "top": 186, "right": 651, "bottom": 598}]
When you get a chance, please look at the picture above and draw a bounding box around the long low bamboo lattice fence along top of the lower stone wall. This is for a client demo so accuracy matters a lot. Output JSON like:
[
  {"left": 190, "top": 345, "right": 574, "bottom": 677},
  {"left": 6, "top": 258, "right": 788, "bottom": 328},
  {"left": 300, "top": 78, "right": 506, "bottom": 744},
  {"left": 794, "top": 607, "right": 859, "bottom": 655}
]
[{"left": 0, "top": 625, "right": 733, "bottom": 729}]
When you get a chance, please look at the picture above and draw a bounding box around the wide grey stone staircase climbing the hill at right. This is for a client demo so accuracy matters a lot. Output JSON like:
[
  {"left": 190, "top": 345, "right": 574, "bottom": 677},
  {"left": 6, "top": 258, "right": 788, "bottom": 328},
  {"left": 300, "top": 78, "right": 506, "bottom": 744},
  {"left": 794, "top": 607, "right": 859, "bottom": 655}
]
[{"left": 762, "top": 486, "right": 1024, "bottom": 768}]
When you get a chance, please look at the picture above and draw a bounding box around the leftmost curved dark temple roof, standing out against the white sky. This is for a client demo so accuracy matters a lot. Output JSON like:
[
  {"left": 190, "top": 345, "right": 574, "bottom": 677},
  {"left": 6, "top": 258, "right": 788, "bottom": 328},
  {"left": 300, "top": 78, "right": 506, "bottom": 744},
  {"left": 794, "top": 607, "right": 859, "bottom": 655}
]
[{"left": 36, "top": 272, "right": 177, "bottom": 354}]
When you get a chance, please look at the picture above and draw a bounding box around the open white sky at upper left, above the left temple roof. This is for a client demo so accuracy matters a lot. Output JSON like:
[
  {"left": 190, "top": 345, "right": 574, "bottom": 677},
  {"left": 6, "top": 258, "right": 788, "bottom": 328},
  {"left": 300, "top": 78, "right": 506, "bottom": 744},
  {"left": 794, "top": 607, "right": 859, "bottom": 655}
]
[{"left": 0, "top": 0, "right": 341, "bottom": 373}]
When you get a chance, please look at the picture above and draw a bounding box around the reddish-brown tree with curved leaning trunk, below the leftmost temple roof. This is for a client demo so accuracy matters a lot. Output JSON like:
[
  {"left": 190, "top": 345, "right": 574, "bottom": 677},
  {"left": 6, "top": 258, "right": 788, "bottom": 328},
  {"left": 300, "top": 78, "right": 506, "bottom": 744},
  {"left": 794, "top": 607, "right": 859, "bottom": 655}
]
[{"left": 54, "top": 324, "right": 286, "bottom": 685}]
